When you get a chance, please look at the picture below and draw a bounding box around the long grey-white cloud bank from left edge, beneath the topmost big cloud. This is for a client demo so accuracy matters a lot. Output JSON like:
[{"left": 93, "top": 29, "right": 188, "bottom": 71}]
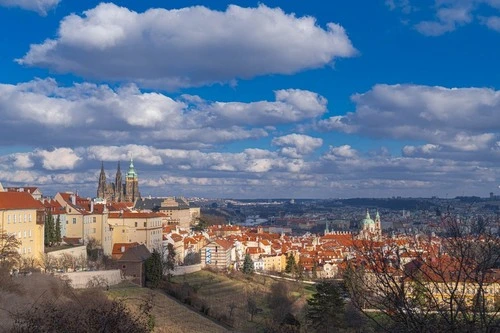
[{"left": 0, "top": 78, "right": 327, "bottom": 147}]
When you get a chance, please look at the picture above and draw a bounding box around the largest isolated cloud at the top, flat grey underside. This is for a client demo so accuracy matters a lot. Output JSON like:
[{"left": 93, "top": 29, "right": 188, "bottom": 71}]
[{"left": 18, "top": 3, "right": 356, "bottom": 89}]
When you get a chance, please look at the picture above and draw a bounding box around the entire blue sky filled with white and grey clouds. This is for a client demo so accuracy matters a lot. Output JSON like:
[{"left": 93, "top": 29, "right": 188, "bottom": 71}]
[{"left": 0, "top": 0, "right": 500, "bottom": 198}]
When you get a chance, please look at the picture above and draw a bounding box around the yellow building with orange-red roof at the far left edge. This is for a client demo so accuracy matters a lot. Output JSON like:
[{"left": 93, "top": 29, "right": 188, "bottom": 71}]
[{"left": 0, "top": 192, "right": 45, "bottom": 259}]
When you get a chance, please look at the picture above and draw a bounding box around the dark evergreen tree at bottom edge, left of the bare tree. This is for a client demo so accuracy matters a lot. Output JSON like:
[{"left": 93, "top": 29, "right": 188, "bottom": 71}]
[{"left": 306, "top": 281, "right": 345, "bottom": 333}]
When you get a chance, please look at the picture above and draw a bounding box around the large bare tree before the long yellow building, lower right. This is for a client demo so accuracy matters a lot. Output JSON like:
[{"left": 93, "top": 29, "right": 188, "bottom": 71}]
[{"left": 345, "top": 215, "right": 500, "bottom": 332}]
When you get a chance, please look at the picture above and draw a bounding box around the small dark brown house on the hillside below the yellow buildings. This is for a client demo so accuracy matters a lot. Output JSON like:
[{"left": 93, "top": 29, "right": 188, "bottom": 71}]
[{"left": 117, "top": 244, "right": 151, "bottom": 287}]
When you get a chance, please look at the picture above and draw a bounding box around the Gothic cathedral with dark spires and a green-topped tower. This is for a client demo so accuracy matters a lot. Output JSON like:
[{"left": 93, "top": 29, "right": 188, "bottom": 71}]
[{"left": 97, "top": 159, "right": 141, "bottom": 202}]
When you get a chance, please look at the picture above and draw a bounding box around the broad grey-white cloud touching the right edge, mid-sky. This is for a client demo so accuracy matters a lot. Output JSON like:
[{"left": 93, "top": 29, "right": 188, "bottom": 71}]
[{"left": 318, "top": 84, "right": 500, "bottom": 151}]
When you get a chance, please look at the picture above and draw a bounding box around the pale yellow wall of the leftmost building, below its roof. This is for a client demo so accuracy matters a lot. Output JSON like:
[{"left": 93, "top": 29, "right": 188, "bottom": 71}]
[{"left": 0, "top": 209, "right": 44, "bottom": 259}]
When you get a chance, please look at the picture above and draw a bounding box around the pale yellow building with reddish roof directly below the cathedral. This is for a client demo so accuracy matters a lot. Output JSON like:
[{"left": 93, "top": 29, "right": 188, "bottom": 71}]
[{"left": 108, "top": 212, "right": 164, "bottom": 251}]
